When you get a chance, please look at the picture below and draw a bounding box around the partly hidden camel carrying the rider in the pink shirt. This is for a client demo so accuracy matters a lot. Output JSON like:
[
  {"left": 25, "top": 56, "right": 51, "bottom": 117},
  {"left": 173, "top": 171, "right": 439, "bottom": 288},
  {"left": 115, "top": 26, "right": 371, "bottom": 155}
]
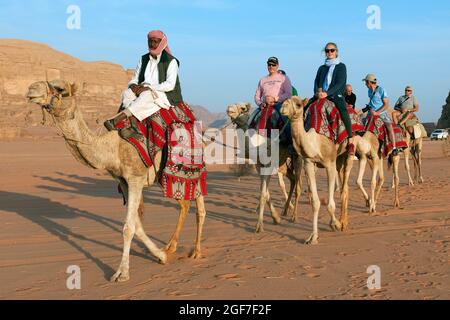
[{"left": 226, "top": 103, "right": 301, "bottom": 233}]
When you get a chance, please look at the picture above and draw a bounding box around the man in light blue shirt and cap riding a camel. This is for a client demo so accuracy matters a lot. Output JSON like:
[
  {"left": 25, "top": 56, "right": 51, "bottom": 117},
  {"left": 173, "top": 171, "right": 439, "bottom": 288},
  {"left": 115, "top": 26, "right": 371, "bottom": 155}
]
[{"left": 362, "top": 74, "right": 398, "bottom": 156}]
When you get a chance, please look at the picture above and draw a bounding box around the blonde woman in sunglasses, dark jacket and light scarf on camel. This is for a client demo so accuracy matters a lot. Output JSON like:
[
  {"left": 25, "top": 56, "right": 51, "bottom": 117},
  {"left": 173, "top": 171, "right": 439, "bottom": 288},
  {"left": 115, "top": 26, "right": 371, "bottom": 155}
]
[{"left": 309, "top": 42, "right": 355, "bottom": 155}]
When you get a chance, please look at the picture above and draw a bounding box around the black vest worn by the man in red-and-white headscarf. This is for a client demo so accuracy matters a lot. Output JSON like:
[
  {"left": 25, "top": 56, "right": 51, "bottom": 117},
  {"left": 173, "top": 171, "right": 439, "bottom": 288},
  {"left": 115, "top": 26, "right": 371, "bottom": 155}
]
[{"left": 138, "top": 50, "right": 183, "bottom": 106}]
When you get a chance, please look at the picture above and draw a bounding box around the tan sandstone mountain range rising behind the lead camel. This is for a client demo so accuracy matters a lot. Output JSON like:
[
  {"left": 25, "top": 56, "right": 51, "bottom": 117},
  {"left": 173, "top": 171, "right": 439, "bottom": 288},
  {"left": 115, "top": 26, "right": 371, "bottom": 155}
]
[{"left": 0, "top": 39, "right": 225, "bottom": 133}]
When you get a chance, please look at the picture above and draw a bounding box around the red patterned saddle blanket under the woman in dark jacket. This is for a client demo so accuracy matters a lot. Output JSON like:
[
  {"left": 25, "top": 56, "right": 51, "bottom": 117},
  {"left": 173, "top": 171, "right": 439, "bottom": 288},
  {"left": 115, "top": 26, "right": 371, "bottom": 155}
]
[{"left": 305, "top": 99, "right": 364, "bottom": 144}]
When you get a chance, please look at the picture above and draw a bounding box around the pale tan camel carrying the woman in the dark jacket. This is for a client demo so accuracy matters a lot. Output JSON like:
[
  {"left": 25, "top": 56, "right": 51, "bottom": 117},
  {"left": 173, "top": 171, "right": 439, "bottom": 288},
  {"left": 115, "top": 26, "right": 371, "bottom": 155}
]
[{"left": 281, "top": 97, "right": 353, "bottom": 244}]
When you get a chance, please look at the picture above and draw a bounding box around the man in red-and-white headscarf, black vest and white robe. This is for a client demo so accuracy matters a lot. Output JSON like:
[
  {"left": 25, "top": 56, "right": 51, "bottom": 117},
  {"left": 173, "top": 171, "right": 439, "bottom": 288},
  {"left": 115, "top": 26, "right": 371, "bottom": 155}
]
[{"left": 104, "top": 30, "right": 183, "bottom": 135}]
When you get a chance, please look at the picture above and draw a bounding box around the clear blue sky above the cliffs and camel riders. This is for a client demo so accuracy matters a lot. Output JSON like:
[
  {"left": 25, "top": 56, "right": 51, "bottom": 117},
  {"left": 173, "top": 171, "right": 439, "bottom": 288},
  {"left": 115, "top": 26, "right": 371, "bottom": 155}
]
[{"left": 0, "top": 0, "right": 450, "bottom": 121}]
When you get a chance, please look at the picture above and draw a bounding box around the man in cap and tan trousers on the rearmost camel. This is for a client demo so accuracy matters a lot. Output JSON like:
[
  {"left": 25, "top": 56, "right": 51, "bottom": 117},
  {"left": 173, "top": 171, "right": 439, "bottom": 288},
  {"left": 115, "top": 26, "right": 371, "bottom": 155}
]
[{"left": 392, "top": 86, "right": 419, "bottom": 134}]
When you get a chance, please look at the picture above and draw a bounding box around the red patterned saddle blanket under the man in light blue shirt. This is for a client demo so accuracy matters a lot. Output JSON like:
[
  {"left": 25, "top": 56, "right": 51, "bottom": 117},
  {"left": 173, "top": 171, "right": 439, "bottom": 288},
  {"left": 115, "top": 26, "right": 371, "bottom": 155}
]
[{"left": 365, "top": 115, "right": 408, "bottom": 157}]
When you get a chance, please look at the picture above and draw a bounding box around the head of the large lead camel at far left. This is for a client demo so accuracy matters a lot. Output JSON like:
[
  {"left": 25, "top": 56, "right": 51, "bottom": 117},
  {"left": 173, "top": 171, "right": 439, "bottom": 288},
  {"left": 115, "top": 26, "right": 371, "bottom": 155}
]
[{"left": 26, "top": 80, "right": 76, "bottom": 116}]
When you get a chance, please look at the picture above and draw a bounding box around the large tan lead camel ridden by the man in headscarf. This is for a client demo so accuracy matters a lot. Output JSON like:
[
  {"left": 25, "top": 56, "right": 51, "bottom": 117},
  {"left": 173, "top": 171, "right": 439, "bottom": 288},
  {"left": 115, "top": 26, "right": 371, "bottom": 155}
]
[{"left": 27, "top": 80, "right": 206, "bottom": 282}]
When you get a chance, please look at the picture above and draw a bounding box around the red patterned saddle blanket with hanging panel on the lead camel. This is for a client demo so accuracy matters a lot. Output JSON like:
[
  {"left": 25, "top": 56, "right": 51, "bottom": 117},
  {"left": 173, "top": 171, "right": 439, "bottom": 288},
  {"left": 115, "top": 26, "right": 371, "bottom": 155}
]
[{"left": 118, "top": 103, "right": 206, "bottom": 200}]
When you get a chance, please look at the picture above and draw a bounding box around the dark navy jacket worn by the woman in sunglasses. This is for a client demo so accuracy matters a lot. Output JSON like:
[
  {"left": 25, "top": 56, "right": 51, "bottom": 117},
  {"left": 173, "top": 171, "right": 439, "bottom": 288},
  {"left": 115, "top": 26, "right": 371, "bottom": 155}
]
[{"left": 314, "top": 63, "right": 347, "bottom": 99}]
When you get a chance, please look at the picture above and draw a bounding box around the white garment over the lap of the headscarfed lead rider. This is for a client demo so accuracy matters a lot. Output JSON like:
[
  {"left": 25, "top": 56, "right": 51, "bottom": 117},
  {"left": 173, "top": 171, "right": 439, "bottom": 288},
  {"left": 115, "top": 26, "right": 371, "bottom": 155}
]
[{"left": 122, "top": 89, "right": 171, "bottom": 121}]
